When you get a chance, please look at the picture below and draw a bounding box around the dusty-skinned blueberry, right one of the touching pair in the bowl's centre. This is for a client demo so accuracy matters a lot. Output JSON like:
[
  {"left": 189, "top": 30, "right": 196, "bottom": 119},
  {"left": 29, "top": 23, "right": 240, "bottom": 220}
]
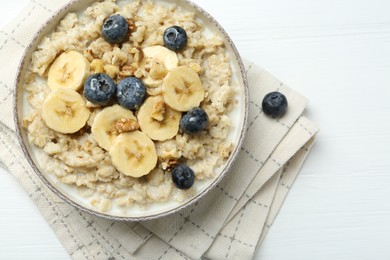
[{"left": 116, "top": 77, "right": 146, "bottom": 109}]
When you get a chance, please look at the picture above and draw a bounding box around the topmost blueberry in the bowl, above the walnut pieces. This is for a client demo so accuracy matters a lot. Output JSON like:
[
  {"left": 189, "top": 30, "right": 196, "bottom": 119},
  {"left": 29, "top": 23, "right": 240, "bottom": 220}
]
[{"left": 102, "top": 14, "right": 129, "bottom": 43}]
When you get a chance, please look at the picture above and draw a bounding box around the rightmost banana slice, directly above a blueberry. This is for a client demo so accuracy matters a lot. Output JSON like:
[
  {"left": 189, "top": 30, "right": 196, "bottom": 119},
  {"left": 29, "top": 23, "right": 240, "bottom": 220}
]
[{"left": 162, "top": 66, "right": 205, "bottom": 111}]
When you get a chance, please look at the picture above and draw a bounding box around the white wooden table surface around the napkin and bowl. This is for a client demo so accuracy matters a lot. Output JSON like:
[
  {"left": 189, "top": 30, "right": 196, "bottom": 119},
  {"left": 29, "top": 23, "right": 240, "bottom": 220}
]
[{"left": 0, "top": 0, "right": 390, "bottom": 260}]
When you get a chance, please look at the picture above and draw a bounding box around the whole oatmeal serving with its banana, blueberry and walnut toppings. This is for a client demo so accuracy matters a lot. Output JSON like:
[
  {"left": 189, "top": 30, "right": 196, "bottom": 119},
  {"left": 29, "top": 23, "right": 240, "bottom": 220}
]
[{"left": 23, "top": 0, "right": 235, "bottom": 212}]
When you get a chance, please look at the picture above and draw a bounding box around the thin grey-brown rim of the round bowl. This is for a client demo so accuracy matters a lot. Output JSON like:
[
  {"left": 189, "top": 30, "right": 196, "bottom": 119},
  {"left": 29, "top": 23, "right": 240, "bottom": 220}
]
[{"left": 13, "top": 0, "right": 249, "bottom": 221}]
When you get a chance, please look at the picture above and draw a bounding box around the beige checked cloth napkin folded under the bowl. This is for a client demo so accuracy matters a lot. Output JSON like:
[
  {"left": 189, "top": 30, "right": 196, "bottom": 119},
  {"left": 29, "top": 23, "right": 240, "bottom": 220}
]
[{"left": 0, "top": 0, "right": 318, "bottom": 259}]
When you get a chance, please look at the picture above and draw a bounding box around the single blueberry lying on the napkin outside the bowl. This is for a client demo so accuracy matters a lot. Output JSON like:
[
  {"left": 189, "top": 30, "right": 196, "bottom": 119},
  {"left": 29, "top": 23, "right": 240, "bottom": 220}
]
[{"left": 262, "top": 91, "right": 287, "bottom": 118}]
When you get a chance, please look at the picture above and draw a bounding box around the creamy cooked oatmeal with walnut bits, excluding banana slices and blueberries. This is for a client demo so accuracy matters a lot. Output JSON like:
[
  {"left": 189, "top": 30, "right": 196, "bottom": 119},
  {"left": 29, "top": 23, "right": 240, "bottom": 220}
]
[{"left": 23, "top": 0, "right": 234, "bottom": 212}]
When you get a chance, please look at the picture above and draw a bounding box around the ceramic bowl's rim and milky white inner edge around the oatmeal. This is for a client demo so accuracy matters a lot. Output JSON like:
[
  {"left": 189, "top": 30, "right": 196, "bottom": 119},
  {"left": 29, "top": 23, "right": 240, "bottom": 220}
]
[{"left": 14, "top": 0, "right": 249, "bottom": 221}]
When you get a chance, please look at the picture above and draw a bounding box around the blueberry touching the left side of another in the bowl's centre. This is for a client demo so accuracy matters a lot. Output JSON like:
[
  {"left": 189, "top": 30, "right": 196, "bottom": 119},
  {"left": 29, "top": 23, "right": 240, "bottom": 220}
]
[{"left": 84, "top": 73, "right": 116, "bottom": 106}]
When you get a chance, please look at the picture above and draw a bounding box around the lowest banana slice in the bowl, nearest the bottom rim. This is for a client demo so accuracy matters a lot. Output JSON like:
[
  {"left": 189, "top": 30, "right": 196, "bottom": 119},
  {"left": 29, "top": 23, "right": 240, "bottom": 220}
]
[{"left": 109, "top": 131, "right": 157, "bottom": 178}]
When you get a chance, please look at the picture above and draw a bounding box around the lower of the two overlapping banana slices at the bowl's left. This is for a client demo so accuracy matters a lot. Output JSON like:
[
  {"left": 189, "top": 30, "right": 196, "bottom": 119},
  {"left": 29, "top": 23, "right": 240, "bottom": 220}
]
[{"left": 42, "top": 88, "right": 90, "bottom": 134}]
